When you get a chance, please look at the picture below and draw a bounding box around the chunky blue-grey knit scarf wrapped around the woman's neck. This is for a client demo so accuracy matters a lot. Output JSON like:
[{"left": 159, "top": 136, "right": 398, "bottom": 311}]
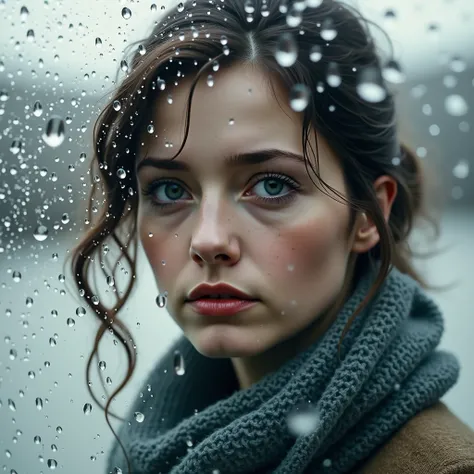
[{"left": 107, "top": 269, "right": 460, "bottom": 474}]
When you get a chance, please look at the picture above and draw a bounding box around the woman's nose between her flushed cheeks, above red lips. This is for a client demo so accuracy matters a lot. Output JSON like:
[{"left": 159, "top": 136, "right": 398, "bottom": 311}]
[{"left": 189, "top": 193, "right": 240, "bottom": 266}]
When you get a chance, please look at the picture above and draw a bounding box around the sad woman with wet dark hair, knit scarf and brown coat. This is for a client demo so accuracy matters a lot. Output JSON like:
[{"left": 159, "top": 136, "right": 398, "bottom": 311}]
[{"left": 68, "top": 0, "right": 474, "bottom": 474}]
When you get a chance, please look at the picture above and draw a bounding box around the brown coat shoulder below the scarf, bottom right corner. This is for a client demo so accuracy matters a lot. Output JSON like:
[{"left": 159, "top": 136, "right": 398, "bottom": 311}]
[{"left": 354, "top": 401, "right": 474, "bottom": 474}]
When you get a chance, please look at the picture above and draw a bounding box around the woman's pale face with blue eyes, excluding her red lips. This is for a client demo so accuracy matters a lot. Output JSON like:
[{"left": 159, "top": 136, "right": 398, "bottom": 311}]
[{"left": 137, "top": 65, "right": 358, "bottom": 357}]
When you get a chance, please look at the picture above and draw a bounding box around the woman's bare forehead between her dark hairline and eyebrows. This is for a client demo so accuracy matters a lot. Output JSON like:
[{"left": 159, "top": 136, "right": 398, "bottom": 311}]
[{"left": 139, "top": 64, "right": 301, "bottom": 159}]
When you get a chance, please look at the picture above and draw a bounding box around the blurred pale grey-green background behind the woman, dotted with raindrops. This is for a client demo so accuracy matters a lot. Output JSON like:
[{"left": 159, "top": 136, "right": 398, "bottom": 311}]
[{"left": 0, "top": 0, "right": 474, "bottom": 474}]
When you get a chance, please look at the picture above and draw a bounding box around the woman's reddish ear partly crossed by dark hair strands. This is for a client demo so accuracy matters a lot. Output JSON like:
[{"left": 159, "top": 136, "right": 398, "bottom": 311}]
[{"left": 352, "top": 175, "right": 398, "bottom": 253}]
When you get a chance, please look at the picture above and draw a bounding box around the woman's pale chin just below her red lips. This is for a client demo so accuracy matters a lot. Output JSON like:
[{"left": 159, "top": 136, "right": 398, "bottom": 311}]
[{"left": 189, "top": 325, "right": 266, "bottom": 358}]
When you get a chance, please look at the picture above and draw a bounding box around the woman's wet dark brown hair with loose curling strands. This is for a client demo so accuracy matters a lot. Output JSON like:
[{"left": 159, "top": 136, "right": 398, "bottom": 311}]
[{"left": 65, "top": 0, "right": 438, "bottom": 469}]
